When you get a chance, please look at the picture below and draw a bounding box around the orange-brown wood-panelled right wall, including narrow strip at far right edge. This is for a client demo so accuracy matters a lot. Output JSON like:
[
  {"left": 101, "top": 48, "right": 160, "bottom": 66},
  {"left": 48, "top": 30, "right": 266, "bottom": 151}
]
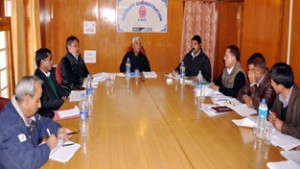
[{"left": 241, "top": 0, "right": 300, "bottom": 85}]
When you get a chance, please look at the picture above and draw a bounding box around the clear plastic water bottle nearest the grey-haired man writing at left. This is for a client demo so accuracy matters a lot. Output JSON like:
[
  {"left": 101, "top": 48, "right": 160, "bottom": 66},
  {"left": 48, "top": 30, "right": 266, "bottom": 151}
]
[{"left": 78, "top": 93, "right": 89, "bottom": 137}]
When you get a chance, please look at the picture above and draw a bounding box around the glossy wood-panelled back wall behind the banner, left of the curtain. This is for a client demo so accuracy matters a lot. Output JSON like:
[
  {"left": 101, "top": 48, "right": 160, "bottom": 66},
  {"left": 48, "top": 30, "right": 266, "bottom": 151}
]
[{"left": 40, "top": 0, "right": 184, "bottom": 73}]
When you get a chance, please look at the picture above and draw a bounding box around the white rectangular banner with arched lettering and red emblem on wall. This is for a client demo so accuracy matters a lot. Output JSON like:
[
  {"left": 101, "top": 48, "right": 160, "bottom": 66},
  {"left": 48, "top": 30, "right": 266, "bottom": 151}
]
[{"left": 116, "top": 0, "right": 168, "bottom": 33}]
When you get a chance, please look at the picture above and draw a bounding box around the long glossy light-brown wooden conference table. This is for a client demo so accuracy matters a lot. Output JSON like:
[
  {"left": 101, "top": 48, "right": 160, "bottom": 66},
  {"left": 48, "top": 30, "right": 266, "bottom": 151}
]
[{"left": 41, "top": 76, "right": 284, "bottom": 169}]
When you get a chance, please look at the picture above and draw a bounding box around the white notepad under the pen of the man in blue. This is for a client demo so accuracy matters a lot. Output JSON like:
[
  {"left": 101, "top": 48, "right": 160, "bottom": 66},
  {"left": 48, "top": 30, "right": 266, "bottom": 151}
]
[{"left": 49, "top": 141, "right": 80, "bottom": 163}]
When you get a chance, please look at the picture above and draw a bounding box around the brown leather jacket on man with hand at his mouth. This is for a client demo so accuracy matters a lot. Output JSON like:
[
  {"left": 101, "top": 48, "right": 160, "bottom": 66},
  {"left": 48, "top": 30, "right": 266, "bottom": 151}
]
[{"left": 237, "top": 72, "right": 276, "bottom": 110}]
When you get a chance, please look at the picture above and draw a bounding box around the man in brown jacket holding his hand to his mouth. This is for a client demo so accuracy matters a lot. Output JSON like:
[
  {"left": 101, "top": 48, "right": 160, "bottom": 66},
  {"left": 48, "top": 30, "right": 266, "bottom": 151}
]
[{"left": 237, "top": 53, "right": 276, "bottom": 110}]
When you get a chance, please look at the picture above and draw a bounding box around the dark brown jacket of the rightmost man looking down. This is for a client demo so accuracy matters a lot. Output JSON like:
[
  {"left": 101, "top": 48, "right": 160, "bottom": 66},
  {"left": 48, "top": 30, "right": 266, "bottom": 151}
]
[{"left": 271, "top": 84, "right": 300, "bottom": 138}]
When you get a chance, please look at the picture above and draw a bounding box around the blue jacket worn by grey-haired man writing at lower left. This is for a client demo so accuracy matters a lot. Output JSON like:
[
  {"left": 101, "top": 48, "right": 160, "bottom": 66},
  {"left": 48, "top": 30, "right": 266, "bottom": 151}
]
[{"left": 0, "top": 102, "right": 61, "bottom": 169}]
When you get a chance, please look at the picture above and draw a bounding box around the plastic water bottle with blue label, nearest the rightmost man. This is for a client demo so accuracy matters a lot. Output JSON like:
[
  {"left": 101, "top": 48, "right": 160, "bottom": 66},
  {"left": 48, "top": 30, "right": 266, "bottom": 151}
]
[{"left": 256, "top": 98, "right": 268, "bottom": 139}]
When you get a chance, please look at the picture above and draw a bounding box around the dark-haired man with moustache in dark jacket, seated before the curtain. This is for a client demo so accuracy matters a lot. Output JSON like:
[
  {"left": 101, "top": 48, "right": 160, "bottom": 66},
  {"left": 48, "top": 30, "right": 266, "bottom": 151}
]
[{"left": 175, "top": 35, "right": 211, "bottom": 82}]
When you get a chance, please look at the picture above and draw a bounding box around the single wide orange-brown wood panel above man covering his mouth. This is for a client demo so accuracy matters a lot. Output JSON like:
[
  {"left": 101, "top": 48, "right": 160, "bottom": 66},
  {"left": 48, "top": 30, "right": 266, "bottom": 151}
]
[{"left": 241, "top": 0, "right": 283, "bottom": 68}]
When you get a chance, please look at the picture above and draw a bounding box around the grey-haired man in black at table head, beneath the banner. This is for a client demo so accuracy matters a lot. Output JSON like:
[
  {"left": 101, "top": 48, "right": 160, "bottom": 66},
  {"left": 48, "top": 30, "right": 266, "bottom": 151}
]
[{"left": 120, "top": 36, "right": 151, "bottom": 72}]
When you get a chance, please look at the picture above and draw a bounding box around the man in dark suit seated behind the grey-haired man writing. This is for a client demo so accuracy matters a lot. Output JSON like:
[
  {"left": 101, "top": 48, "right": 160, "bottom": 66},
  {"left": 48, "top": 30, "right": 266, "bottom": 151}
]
[{"left": 34, "top": 48, "right": 66, "bottom": 118}]
